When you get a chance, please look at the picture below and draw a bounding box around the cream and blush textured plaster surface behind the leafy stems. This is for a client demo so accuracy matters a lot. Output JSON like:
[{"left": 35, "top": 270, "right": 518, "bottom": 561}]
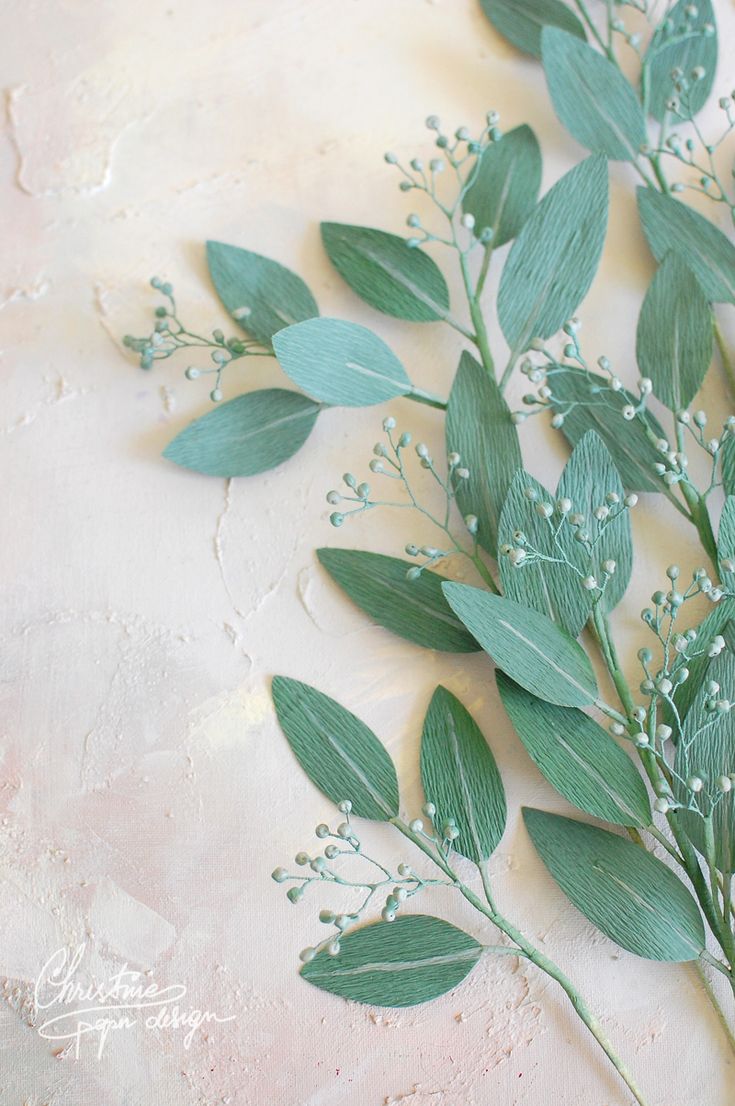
[{"left": 0, "top": 0, "right": 735, "bottom": 1106}]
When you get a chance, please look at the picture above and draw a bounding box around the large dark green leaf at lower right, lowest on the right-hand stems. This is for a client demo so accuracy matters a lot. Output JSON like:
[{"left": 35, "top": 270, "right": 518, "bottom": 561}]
[{"left": 523, "top": 807, "right": 704, "bottom": 962}]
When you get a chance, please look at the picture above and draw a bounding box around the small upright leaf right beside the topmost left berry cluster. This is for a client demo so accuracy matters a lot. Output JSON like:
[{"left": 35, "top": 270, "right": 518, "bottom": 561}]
[{"left": 462, "top": 124, "right": 542, "bottom": 248}]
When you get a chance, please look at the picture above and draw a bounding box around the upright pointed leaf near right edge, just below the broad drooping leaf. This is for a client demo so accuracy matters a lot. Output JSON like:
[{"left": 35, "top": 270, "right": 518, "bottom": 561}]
[{"left": 636, "top": 252, "right": 714, "bottom": 411}]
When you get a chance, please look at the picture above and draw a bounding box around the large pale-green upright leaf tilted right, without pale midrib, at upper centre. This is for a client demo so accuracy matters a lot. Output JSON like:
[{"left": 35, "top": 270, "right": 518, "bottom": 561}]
[{"left": 497, "top": 154, "right": 608, "bottom": 353}]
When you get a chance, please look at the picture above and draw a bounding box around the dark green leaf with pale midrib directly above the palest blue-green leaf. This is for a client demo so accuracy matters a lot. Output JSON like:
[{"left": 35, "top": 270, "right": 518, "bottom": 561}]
[{"left": 322, "top": 222, "right": 449, "bottom": 323}]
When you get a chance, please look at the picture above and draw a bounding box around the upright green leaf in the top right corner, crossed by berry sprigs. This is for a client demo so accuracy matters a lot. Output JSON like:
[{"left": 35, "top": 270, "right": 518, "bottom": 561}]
[{"left": 641, "top": 0, "right": 717, "bottom": 123}]
